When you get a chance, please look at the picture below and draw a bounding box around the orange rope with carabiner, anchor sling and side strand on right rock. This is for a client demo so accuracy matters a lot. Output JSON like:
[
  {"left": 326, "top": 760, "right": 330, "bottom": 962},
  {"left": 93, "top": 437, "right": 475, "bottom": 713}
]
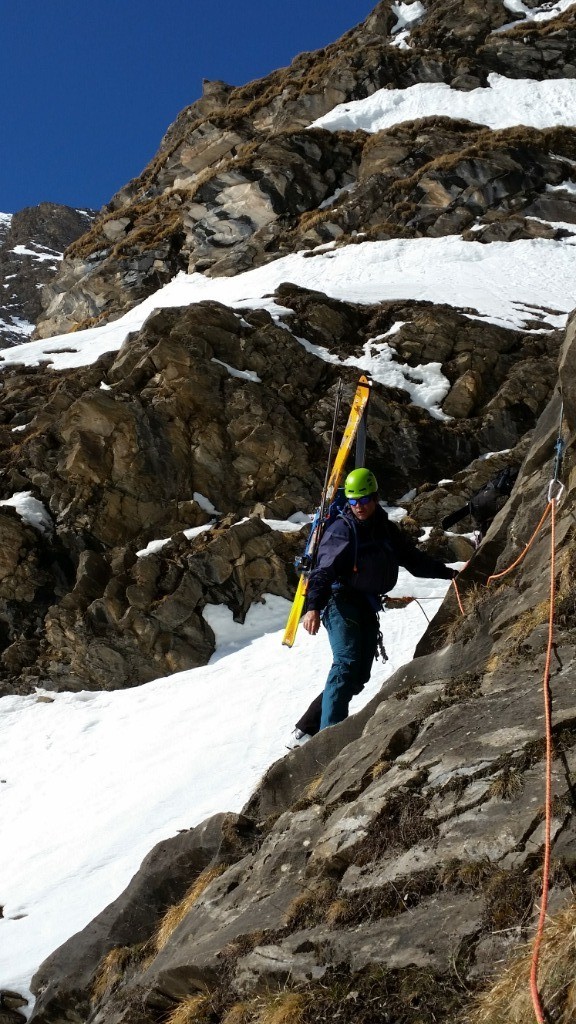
[{"left": 487, "top": 403, "right": 566, "bottom": 1024}]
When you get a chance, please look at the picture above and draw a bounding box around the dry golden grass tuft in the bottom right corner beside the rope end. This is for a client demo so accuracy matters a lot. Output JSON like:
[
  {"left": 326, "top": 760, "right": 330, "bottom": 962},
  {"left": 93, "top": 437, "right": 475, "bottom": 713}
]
[{"left": 463, "top": 906, "right": 576, "bottom": 1024}]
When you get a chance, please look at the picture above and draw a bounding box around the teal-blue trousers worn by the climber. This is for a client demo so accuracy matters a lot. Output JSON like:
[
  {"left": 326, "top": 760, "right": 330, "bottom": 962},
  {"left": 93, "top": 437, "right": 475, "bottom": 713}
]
[{"left": 320, "top": 594, "right": 378, "bottom": 729}]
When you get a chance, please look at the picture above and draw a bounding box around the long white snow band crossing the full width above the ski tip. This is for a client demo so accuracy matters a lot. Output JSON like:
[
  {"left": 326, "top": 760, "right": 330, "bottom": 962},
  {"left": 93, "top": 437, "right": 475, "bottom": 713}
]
[{"left": 0, "top": 234, "right": 576, "bottom": 370}]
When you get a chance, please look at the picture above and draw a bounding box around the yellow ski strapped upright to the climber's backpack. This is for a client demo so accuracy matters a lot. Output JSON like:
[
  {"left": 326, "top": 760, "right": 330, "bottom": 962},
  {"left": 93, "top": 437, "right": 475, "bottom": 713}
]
[{"left": 282, "top": 376, "right": 370, "bottom": 647}]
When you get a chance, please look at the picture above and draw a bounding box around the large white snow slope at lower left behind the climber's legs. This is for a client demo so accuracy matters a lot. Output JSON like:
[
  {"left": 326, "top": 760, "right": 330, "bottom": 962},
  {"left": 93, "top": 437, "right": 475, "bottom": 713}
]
[{"left": 0, "top": 570, "right": 449, "bottom": 1007}]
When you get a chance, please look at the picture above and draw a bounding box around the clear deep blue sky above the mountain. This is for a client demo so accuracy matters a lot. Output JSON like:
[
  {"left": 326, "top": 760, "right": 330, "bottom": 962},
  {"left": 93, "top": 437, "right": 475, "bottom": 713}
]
[{"left": 0, "top": 0, "right": 376, "bottom": 213}]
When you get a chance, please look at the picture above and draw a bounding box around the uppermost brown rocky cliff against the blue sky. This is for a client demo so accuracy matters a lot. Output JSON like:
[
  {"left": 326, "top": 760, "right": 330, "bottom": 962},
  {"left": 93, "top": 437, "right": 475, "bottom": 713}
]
[{"left": 32, "top": 0, "right": 576, "bottom": 337}]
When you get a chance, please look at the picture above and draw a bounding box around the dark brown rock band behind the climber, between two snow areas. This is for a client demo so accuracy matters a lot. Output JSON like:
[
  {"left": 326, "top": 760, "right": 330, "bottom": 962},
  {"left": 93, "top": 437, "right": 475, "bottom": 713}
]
[{"left": 0, "top": 285, "right": 560, "bottom": 693}]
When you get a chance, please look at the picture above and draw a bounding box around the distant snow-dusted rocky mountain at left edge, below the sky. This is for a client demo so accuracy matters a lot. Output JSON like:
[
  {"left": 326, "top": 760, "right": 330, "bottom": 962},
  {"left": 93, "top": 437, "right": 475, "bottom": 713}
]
[{"left": 0, "top": 203, "right": 95, "bottom": 348}]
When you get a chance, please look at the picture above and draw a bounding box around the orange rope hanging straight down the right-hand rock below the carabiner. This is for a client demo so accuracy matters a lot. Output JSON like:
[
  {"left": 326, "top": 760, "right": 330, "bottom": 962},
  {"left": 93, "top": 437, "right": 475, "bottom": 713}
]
[{"left": 530, "top": 498, "right": 556, "bottom": 1024}]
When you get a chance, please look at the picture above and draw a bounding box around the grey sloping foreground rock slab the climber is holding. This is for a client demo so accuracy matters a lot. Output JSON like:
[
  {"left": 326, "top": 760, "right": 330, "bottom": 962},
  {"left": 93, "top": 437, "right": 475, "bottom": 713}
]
[{"left": 32, "top": 319, "right": 576, "bottom": 1024}]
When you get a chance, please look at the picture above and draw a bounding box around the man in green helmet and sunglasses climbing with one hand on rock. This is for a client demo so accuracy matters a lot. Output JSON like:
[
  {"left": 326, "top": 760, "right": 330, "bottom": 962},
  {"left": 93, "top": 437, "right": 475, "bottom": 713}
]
[{"left": 290, "top": 469, "right": 456, "bottom": 746}]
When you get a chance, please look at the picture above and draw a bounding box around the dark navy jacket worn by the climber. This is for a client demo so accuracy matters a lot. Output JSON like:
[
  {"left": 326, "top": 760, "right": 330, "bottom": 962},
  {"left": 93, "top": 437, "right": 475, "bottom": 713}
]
[{"left": 306, "top": 505, "right": 456, "bottom": 611}]
